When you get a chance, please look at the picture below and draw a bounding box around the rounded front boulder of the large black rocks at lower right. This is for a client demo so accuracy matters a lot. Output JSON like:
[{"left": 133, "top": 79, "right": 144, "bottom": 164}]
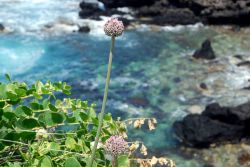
[{"left": 173, "top": 114, "right": 244, "bottom": 147}]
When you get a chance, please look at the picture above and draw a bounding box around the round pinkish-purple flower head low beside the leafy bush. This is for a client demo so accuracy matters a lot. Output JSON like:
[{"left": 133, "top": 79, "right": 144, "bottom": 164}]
[{"left": 105, "top": 136, "right": 129, "bottom": 157}]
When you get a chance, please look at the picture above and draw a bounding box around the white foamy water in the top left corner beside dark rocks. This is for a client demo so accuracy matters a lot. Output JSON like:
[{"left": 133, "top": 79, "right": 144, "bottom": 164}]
[{"left": 0, "top": 0, "right": 80, "bottom": 33}]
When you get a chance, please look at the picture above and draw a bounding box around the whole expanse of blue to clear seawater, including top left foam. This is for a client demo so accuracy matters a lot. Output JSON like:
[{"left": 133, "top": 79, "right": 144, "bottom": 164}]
[{"left": 0, "top": 0, "right": 250, "bottom": 167}]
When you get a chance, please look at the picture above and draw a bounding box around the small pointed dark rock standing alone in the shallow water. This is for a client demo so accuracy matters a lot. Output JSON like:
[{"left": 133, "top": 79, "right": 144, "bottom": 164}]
[{"left": 193, "top": 39, "right": 216, "bottom": 60}]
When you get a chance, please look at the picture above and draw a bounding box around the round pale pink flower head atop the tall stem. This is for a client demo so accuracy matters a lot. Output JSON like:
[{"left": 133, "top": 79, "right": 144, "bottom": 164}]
[{"left": 104, "top": 18, "right": 124, "bottom": 37}]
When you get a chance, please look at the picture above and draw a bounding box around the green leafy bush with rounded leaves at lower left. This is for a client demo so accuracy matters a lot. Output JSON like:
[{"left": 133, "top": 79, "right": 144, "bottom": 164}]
[{"left": 0, "top": 75, "right": 125, "bottom": 167}]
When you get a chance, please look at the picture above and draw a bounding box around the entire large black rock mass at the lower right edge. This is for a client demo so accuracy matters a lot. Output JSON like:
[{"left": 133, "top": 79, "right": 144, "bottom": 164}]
[{"left": 173, "top": 102, "right": 250, "bottom": 148}]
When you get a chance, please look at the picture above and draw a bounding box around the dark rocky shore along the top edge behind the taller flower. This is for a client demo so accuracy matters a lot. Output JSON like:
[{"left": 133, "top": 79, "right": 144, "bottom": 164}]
[{"left": 80, "top": 0, "right": 250, "bottom": 26}]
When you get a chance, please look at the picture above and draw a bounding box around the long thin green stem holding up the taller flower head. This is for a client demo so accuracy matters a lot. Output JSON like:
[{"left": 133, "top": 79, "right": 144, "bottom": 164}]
[{"left": 87, "top": 36, "right": 115, "bottom": 167}]
